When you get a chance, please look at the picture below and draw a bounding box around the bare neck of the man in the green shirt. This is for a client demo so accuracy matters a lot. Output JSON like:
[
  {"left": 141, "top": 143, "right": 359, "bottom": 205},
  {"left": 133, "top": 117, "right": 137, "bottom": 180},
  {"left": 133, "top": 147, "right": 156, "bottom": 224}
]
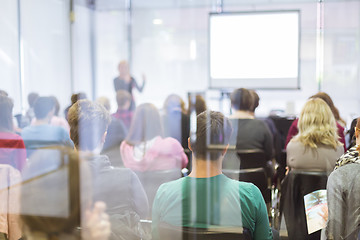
[{"left": 189, "top": 157, "right": 222, "bottom": 178}]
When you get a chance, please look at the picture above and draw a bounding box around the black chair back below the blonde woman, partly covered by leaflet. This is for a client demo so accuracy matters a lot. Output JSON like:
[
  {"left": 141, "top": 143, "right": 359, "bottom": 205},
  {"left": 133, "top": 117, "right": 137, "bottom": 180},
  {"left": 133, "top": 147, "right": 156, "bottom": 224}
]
[{"left": 280, "top": 170, "right": 328, "bottom": 240}]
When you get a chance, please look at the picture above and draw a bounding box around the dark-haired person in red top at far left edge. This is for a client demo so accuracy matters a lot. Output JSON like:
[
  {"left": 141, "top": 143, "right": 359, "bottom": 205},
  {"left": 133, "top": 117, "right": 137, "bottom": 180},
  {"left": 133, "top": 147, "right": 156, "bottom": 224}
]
[{"left": 0, "top": 95, "right": 26, "bottom": 171}]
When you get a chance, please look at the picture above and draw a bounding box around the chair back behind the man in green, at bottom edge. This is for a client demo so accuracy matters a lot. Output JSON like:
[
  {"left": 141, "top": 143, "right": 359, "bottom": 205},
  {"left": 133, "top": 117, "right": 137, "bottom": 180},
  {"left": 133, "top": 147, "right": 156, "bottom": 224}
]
[{"left": 159, "top": 223, "right": 252, "bottom": 240}]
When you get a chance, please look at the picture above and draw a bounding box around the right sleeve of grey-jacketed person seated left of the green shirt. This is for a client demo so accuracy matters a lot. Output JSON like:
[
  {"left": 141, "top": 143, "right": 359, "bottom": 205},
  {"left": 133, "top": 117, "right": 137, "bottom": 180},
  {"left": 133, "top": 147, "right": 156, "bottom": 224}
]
[{"left": 130, "top": 171, "right": 149, "bottom": 219}]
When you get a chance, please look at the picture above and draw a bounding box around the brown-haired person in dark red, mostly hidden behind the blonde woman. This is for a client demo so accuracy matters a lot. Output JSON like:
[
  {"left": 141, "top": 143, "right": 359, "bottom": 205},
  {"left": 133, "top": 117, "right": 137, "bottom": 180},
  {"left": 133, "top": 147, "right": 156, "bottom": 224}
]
[{"left": 285, "top": 92, "right": 347, "bottom": 151}]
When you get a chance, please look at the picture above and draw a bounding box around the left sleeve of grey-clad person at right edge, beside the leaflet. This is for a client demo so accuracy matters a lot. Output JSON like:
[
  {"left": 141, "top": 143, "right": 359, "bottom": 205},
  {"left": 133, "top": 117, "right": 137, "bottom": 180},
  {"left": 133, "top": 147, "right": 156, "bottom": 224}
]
[{"left": 326, "top": 170, "right": 346, "bottom": 240}]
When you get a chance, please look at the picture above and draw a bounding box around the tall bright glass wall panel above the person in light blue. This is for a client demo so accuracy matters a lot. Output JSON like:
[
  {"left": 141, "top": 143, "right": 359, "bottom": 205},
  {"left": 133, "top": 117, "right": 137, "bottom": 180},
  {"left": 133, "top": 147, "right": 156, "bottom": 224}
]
[{"left": 21, "top": 0, "right": 71, "bottom": 116}]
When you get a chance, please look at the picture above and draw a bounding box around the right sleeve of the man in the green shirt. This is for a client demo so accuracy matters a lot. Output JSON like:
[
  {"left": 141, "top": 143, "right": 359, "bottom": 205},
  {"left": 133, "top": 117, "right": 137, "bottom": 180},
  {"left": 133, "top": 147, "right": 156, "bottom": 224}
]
[{"left": 252, "top": 185, "right": 273, "bottom": 240}]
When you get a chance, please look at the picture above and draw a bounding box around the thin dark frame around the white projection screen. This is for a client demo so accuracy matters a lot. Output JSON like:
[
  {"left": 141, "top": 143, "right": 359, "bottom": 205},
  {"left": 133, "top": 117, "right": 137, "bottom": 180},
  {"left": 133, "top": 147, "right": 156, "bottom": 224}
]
[{"left": 208, "top": 9, "right": 301, "bottom": 91}]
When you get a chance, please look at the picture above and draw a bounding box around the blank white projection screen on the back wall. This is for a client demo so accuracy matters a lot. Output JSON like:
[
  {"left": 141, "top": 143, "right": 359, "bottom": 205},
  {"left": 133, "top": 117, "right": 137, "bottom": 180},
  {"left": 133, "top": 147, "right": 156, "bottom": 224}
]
[{"left": 209, "top": 10, "right": 300, "bottom": 89}]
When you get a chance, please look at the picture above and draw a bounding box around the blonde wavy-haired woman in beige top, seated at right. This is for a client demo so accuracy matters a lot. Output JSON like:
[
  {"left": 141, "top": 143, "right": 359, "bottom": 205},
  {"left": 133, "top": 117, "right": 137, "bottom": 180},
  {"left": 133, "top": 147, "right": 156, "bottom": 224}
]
[{"left": 286, "top": 98, "right": 344, "bottom": 173}]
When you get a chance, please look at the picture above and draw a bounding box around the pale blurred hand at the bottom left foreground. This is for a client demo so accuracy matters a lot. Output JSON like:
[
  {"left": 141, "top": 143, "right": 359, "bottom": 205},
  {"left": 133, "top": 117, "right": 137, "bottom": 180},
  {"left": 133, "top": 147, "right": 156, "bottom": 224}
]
[{"left": 82, "top": 202, "right": 111, "bottom": 240}]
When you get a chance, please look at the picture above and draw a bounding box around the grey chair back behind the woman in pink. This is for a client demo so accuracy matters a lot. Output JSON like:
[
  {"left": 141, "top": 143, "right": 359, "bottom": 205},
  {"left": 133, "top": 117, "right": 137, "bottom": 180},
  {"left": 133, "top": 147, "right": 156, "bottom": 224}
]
[{"left": 135, "top": 169, "right": 181, "bottom": 213}]
